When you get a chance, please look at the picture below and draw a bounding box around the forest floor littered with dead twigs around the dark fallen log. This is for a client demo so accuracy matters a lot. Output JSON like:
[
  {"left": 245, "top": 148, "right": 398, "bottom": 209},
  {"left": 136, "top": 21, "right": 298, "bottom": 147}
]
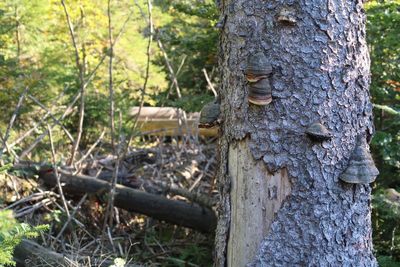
[{"left": 0, "top": 137, "right": 217, "bottom": 266}]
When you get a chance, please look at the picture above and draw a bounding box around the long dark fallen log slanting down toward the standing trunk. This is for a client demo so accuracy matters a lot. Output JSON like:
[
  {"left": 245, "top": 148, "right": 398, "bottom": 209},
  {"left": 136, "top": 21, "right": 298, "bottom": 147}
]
[{"left": 39, "top": 170, "right": 217, "bottom": 233}]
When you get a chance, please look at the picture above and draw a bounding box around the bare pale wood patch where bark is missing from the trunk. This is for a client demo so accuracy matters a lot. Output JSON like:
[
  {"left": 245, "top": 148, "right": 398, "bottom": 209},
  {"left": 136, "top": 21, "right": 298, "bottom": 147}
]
[{"left": 227, "top": 139, "right": 291, "bottom": 267}]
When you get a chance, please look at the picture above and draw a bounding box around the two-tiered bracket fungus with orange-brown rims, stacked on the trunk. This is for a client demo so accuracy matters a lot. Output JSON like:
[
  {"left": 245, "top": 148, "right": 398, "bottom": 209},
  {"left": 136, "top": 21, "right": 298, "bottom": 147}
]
[{"left": 245, "top": 52, "right": 272, "bottom": 106}]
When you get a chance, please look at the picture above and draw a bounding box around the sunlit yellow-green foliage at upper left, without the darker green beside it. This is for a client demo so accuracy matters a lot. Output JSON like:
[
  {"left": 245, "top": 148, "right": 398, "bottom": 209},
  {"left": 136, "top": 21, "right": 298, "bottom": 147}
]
[{"left": 0, "top": 0, "right": 167, "bottom": 151}]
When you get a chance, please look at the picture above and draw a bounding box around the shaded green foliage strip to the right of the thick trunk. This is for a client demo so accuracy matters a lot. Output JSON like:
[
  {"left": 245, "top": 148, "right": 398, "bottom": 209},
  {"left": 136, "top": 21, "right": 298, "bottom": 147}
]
[{"left": 366, "top": 0, "right": 400, "bottom": 182}]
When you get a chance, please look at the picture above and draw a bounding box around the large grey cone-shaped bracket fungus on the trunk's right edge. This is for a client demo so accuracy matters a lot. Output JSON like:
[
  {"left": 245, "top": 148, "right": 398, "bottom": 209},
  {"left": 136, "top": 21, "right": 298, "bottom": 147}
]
[{"left": 339, "top": 136, "right": 379, "bottom": 184}]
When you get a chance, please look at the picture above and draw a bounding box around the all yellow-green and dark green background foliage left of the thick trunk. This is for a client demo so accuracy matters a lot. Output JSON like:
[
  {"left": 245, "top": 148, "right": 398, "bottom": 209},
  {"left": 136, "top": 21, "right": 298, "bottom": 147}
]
[{"left": 0, "top": 0, "right": 218, "bottom": 157}]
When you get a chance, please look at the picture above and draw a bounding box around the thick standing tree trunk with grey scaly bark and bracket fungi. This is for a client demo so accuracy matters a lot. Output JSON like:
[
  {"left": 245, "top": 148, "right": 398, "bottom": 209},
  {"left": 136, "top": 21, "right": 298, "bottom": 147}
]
[{"left": 215, "top": 0, "right": 377, "bottom": 267}]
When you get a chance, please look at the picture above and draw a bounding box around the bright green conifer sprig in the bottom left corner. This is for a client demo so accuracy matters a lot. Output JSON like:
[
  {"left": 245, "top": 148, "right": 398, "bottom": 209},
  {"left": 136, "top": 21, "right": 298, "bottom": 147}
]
[{"left": 0, "top": 210, "right": 48, "bottom": 266}]
